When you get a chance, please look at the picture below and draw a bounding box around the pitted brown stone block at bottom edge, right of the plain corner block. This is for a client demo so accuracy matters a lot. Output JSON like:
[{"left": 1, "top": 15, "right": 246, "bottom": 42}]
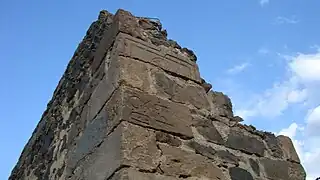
[{"left": 160, "top": 144, "right": 226, "bottom": 180}]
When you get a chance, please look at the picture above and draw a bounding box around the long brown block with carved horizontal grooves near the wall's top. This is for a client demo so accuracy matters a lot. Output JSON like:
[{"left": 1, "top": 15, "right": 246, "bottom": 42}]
[{"left": 116, "top": 33, "right": 201, "bottom": 83}]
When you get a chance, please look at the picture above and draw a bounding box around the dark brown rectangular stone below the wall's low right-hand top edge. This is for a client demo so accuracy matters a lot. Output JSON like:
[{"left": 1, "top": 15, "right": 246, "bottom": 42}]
[{"left": 226, "top": 128, "right": 266, "bottom": 156}]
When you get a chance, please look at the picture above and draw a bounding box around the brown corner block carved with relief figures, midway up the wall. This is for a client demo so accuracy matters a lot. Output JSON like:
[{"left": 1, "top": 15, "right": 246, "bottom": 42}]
[{"left": 101, "top": 86, "right": 193, "bottom": 139}]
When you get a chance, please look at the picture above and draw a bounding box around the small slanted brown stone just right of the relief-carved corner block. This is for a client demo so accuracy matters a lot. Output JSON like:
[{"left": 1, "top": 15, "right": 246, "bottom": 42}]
[{"left": 193, "top": 117, "right": 224, "bottom": 144}]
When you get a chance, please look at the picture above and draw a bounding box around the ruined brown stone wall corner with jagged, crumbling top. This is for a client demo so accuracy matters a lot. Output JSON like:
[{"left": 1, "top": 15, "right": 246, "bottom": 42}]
[{"left": 9, "top": 10, "right": 306, "bottom": 180}]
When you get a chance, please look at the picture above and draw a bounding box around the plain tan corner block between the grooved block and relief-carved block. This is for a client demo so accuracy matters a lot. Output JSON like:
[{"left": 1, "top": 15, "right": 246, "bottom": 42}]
[{"left": 82, "top": 54, "right": 150, "bottom": 124}]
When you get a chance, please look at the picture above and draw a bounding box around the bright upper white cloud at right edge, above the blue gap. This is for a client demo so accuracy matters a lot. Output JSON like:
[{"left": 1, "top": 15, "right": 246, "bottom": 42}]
[{"left": 236, "top": 51, "right": 320, "bottom": 119}]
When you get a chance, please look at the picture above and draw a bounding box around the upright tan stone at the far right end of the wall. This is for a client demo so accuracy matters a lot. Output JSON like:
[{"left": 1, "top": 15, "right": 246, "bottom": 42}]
[{"left": 277, "top": 135, "right": 300, "bottom": 163}]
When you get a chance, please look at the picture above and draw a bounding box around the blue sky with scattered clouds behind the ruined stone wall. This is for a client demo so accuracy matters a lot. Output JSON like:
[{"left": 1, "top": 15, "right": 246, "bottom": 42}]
[{"left": 0, "top": 0, "right": 320, "bottom": 180}]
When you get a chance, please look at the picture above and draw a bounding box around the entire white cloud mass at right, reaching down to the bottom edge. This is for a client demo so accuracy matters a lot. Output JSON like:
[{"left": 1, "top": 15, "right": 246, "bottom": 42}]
[{"left": 220, "top": 48, "right": 320, "bottom": 180}]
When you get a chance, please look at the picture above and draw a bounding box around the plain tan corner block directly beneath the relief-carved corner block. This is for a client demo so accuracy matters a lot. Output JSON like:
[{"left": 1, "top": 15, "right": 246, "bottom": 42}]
[{"left": 68, "top": 122, "right": 161, "bottom": 180}]
